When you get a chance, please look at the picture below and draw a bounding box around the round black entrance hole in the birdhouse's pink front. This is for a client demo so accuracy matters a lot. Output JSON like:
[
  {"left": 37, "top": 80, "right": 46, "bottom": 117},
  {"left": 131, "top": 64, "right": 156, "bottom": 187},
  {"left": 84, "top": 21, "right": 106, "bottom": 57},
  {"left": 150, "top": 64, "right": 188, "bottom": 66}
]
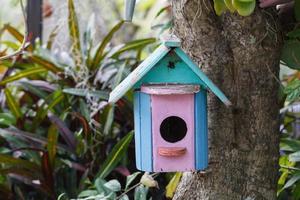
[{"left": 160, "top": 116, "right": 187, "bottom": 143}]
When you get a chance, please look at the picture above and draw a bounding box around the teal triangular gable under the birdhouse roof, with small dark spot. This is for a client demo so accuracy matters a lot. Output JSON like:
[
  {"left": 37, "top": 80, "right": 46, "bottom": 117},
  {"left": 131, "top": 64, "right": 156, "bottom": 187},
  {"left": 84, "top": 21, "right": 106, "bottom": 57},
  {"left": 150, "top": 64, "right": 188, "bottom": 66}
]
[{"left": 134, "top": 51, "right": 205, "bottom": 88}]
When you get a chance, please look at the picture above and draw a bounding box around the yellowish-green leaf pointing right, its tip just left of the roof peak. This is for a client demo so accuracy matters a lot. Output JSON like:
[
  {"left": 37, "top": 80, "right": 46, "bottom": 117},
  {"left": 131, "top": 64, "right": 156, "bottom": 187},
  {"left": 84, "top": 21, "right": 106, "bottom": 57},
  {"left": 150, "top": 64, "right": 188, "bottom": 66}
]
[{"left": 111, "top": 38, "right": 156, "bottom": 58}]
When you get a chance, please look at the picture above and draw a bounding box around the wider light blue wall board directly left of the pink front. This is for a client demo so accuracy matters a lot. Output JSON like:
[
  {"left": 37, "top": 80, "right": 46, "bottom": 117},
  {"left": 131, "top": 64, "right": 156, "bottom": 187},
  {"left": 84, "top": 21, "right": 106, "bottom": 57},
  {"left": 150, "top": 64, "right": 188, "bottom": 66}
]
[{"left": 140, "top": 92, "right": 153, "bottom": 172}]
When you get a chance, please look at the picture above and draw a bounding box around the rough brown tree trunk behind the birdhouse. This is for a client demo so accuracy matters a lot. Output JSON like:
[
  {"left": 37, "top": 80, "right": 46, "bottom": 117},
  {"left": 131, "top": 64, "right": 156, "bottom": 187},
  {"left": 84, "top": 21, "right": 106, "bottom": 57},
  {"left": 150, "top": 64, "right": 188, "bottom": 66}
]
[{"left": 172, "top": 0, "right": 282, "bottom": 200}]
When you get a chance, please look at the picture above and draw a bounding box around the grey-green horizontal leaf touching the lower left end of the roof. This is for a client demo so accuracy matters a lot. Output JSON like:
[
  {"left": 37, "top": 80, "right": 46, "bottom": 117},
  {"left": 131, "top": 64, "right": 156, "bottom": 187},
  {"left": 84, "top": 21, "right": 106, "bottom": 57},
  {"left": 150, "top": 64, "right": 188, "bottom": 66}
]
[{"left": 63, "top": 88, "right": 109, "bottom": 100}]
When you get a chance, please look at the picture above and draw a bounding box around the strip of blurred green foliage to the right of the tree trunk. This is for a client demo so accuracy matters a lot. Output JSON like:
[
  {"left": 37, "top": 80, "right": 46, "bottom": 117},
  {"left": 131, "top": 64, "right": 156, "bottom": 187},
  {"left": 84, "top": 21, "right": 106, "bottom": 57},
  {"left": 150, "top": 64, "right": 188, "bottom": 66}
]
[{"left": 278, "top": 9, "right": 300, "bottom": 200}]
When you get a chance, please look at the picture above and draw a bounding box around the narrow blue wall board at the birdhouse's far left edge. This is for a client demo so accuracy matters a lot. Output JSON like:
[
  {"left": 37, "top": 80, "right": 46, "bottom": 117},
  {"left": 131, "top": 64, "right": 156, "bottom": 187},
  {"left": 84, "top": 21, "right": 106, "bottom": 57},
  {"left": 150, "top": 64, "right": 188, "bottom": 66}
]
[{"left": 133, "top": 91, "right": 142, "bottom": 170}]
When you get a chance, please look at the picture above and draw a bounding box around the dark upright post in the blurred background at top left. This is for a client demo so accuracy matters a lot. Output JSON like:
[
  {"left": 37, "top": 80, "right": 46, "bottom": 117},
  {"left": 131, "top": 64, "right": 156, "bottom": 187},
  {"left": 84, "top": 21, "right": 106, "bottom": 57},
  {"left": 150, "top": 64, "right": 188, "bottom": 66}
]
[{"left": 26, "top": 0, "right": 43, "bottom": 44}]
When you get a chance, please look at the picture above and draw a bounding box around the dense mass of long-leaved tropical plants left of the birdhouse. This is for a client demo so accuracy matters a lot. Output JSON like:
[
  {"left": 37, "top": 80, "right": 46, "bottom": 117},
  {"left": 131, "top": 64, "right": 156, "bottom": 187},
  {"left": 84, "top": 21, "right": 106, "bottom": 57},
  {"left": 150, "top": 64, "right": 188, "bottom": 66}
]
[{"left": 0, "top": 0, "right": 155, "bottom": 199}]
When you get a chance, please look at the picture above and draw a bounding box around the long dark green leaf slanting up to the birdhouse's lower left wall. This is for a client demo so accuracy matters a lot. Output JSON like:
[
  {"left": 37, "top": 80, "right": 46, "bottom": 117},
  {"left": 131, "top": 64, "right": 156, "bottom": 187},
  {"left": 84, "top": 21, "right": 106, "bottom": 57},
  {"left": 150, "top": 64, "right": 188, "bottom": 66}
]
[{"left": 97, "top": 132, "right": 133, "bottom": 178}]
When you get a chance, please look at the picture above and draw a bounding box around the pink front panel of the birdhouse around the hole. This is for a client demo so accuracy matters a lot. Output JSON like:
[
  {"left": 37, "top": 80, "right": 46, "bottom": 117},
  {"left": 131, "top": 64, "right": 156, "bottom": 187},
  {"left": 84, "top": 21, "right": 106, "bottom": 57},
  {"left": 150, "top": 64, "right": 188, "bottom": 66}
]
[{"left": 151, "top": 94, "right": 195, "bottom": 172}]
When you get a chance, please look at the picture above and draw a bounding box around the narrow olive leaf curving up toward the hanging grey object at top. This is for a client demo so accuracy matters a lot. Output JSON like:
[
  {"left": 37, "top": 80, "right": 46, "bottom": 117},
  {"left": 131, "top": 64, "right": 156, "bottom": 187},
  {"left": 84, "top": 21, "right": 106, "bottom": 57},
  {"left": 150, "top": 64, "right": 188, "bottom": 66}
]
[{"left": 91, "top": 21, "right": 124, "bottom": 69}]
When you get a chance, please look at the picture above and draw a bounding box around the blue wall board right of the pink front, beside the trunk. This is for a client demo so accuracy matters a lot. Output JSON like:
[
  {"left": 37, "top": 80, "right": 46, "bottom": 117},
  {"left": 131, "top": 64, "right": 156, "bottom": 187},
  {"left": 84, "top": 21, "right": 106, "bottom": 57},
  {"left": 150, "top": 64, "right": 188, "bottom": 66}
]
[{"left": 195, "top": 88, "right": 208, "bottom": 170}]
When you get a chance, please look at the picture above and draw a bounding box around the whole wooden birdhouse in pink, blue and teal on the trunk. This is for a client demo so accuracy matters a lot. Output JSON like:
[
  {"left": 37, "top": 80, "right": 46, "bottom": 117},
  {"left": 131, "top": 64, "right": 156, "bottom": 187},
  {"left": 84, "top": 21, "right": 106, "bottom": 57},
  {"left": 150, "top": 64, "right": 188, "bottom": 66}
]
[{"left": 109, "top": 34, "right": 230, "bottom": 172}]
